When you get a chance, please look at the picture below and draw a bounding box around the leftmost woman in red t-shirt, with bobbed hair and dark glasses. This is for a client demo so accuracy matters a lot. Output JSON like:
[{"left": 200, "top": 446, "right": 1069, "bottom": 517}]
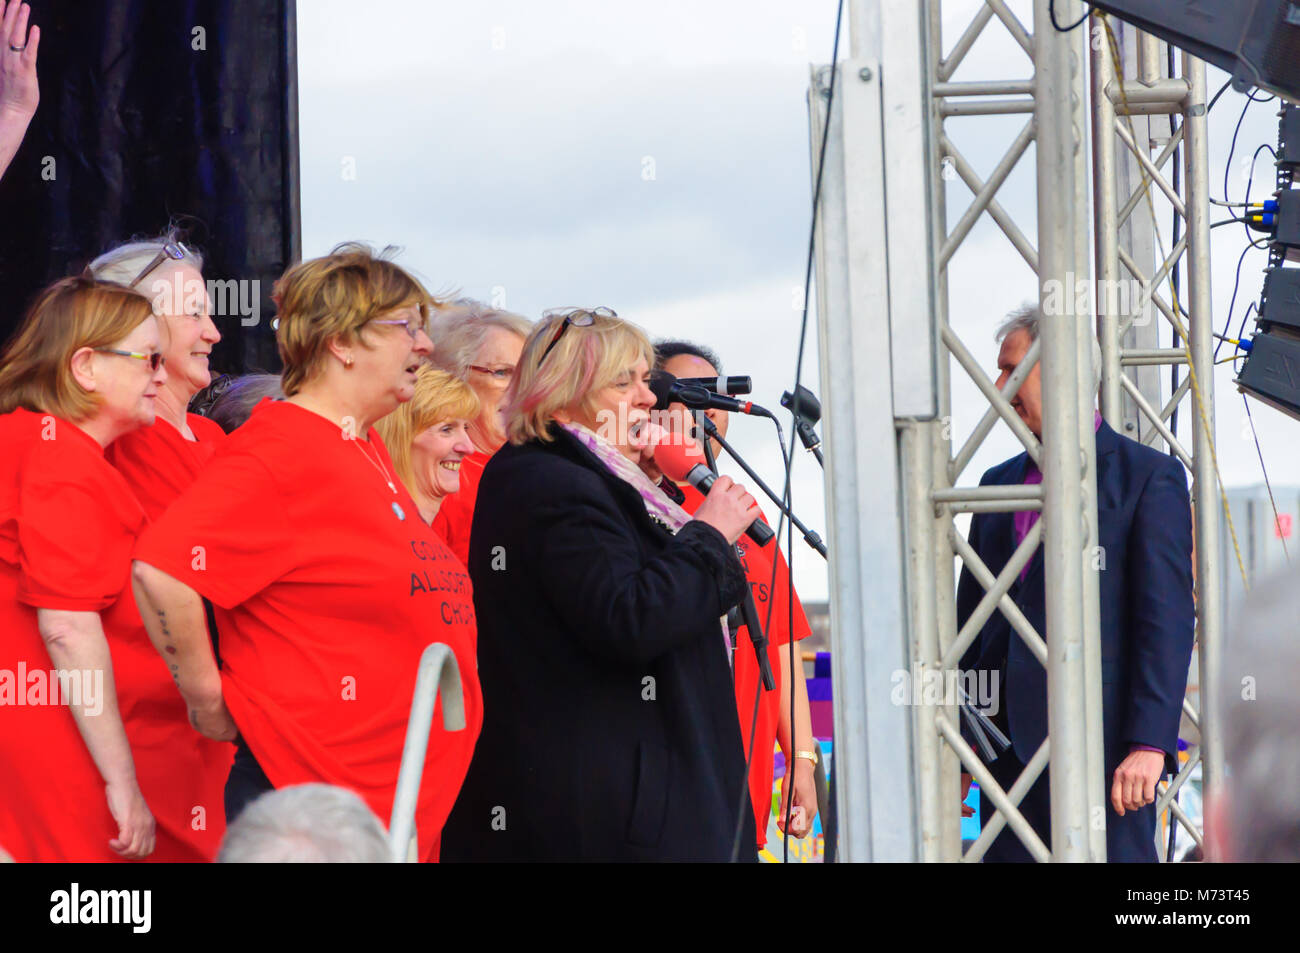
[{"left": 0, "top": 277, "right": 166, "bottom": 862}]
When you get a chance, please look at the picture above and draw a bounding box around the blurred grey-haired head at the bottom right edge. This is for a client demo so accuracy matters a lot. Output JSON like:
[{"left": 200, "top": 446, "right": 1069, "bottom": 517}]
[{"left": 1206, "top": 568, "right": 1300, "bottom": 863}]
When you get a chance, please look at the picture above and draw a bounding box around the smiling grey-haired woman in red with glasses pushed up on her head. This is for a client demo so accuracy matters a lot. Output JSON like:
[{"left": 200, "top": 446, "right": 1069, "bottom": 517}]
[{"left": 90, "top": 237, "right": 235, "bottom": 862}]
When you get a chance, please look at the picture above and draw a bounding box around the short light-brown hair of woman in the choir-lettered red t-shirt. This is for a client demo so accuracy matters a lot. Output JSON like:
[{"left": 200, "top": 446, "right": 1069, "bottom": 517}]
[{"left": 272, "top": 242, "right": 438, "bottom": 397}]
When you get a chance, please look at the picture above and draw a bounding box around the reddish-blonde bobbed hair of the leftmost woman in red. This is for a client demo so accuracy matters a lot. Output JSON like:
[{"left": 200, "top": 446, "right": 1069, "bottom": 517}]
[{"left": 0, "top": 276, "right": 153, "bottom": 423}]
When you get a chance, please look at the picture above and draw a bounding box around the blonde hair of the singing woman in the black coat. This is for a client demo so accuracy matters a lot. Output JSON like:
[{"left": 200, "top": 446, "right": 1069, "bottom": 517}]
[{"left": 503, "top": 313, "right": 654, "bottom": 445}]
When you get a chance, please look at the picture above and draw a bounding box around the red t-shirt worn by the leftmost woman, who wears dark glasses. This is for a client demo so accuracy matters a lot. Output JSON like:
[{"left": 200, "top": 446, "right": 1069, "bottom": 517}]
[{"left": 0, "top": 410, "right": 153, "bottom": 862}]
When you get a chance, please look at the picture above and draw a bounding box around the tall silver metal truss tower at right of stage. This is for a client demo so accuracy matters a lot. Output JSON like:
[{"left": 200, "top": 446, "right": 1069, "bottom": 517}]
[{"left": 809, "top": 0, "right": 1222, "bottom": 861}]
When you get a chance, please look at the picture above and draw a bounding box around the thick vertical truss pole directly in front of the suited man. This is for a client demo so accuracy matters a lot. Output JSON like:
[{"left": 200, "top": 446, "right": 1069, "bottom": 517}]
[{"left": 1034, "top": 0, "right": 1100, "bottom": 861}]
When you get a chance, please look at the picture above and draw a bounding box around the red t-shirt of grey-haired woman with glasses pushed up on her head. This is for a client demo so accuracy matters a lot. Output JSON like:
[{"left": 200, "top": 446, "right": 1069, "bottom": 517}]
[{"left": 104, "top": 413, "right": 235, "bottom": 861}]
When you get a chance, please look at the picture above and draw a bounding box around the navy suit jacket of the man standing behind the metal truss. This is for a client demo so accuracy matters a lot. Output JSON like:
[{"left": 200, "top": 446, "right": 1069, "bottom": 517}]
[{"left": 957, "top": 423, "right": 1195, "bottom": 859}]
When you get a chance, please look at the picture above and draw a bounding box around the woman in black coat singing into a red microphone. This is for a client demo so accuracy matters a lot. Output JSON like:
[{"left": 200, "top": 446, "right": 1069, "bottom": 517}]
[{"left": 442, "top": 308, "right": 757, "bottom": 861}]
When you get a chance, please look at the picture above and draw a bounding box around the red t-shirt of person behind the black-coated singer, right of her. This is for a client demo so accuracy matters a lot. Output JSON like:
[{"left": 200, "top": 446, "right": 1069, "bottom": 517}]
[{"left": 680, "top": 485, "right": 813, "bottom": 846}]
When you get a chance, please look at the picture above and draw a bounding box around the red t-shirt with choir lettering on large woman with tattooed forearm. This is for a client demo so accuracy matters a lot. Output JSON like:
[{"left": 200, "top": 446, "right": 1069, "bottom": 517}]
[{"left": 135, "top": 400, "right": 482, "bottom": 859}]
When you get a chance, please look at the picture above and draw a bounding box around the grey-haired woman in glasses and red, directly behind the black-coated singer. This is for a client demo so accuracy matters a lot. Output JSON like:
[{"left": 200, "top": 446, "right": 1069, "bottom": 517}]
[{"left": 429, "top": 298, "right": 533, "bottom": 566}]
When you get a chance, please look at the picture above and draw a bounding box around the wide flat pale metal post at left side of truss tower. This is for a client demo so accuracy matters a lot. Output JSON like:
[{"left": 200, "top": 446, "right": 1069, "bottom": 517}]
[{"left": 810, "top": 0, "right": 924, "bottom": 862}]
